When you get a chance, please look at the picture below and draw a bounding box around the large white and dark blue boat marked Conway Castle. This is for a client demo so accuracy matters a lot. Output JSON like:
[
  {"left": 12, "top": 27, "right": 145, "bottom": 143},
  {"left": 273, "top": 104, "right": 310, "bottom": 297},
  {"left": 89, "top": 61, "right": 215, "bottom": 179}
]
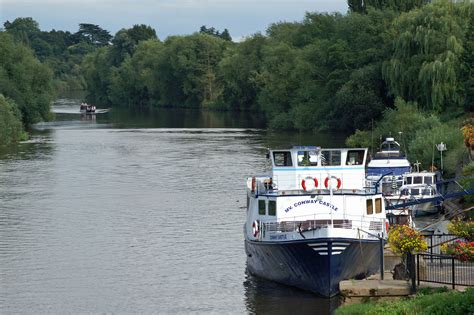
[{"left": 244, "top": 147, "right": 388, "bottom": 297}]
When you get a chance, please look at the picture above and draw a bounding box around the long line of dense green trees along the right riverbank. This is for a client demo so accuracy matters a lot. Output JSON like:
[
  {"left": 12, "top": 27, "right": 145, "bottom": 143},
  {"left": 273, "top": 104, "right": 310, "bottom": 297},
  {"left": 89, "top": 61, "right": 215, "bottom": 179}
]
[{"left": 82, "top": 0, "right": 474, "bottom": 131}]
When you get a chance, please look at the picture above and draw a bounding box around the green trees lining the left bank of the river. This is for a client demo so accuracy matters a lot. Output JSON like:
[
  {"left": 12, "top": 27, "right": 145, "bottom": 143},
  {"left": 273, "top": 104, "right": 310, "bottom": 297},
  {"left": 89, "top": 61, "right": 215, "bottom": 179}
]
[{"left": 0, "top": 18, "right": 112, "bottom": 145}]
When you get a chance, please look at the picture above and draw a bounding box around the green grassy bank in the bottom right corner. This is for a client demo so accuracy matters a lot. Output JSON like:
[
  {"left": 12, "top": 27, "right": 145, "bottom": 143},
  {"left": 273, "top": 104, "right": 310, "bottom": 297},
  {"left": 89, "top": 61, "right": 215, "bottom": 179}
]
[{"left": 336, "top": 288, "right": 474, "bottom": 315}]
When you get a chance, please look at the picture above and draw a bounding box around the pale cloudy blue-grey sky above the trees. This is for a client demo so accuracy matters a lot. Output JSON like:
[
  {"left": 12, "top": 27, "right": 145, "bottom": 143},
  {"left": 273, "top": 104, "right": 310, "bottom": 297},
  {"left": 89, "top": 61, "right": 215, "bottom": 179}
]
[{"left": 0, "top": 0, "right": 347, "bottom": 40}]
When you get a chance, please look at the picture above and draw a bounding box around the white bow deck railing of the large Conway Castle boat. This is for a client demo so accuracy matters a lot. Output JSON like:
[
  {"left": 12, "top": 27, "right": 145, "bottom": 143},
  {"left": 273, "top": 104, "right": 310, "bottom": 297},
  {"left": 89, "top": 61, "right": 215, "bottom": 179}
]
[{"left": 261, "top": 214, "right": 385, "bottom": 234}]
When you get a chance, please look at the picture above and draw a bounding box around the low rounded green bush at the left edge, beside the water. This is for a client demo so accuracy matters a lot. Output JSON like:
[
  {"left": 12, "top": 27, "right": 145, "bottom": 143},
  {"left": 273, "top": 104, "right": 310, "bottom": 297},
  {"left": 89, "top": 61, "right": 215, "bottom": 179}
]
[{"left": 0, "top": 94, "right": 24, "bottom": 146}]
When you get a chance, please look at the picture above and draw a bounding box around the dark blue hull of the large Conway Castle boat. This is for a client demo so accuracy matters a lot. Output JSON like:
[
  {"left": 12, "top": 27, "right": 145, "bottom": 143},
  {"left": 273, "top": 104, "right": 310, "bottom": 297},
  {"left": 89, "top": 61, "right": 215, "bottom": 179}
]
[{"left": 245, "top": 238, "right": 380, "bottom": 297}]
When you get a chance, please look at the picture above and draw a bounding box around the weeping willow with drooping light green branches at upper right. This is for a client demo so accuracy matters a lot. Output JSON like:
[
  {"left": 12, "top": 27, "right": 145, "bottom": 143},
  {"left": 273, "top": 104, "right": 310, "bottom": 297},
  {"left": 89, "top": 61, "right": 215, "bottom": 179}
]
[{"left": 383, "top": 1, "right": 472, "bottom": 111}]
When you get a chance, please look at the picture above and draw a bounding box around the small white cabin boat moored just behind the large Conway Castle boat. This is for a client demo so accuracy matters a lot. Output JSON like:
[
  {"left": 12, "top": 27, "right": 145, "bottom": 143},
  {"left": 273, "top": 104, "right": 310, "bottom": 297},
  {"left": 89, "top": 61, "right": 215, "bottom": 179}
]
[{"left": 400, "top": 171, "right": 443, "bottom": 217}]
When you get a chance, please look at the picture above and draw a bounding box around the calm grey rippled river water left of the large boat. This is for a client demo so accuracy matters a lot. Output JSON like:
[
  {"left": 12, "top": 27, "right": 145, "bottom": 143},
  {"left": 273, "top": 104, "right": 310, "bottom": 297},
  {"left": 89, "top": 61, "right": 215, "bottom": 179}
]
[{"left": 0, "top": 99, "right": 344, "bottom": 314}]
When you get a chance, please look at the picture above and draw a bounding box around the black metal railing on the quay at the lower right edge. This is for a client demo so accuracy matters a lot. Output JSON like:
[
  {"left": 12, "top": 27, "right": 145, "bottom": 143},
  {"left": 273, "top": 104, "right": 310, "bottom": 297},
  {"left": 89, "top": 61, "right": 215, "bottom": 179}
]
[{"left": 416, "top": 254, "right": 474, "bottom": 289}]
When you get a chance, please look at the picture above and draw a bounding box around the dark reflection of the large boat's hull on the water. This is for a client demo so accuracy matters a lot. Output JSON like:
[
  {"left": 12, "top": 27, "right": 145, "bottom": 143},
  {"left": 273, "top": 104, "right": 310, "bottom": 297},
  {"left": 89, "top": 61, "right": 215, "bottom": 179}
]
[{"left": 243, "top": 271, "right": 341, "bottom": 314}]
